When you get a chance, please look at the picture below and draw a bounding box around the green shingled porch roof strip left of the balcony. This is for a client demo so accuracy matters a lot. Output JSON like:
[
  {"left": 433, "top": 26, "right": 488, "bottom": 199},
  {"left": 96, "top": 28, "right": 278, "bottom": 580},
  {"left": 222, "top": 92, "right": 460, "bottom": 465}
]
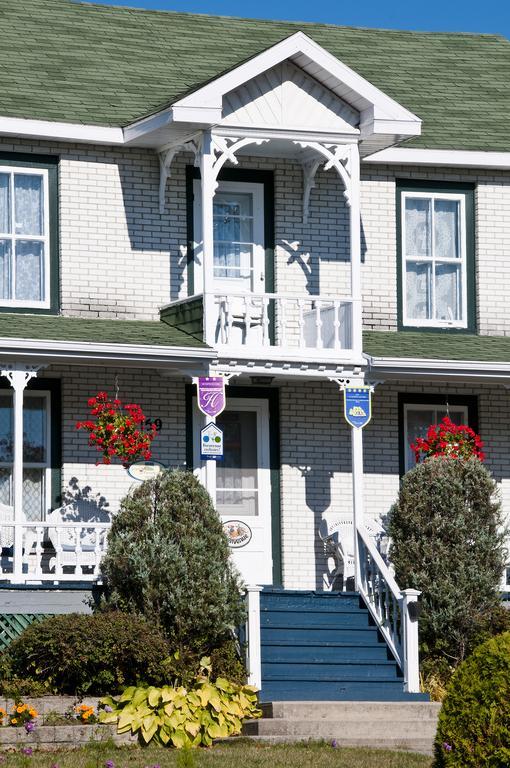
[{"left": 0, "top": 313, "right": 208, "bottom": 349}]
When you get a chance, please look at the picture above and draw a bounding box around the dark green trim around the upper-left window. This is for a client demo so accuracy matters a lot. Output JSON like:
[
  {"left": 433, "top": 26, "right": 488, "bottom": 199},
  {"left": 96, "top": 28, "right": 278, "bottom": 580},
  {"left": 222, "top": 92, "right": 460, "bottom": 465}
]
[{"left": 0, "top": 152, "right": 60, "bottom": 315}]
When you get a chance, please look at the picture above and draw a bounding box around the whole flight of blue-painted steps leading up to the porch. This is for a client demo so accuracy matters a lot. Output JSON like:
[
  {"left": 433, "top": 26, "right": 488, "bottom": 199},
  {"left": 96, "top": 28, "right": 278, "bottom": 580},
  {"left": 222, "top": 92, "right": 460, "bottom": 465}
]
[{"left": 260, "top": 588, "right": 428, "bottom": 702}]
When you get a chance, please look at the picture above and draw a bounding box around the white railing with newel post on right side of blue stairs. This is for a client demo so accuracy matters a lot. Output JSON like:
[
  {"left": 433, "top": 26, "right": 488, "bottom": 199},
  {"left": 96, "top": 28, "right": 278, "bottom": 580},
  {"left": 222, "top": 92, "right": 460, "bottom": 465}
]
[{"left": 357, "top": 525, "right": 421, "bottom": 693}]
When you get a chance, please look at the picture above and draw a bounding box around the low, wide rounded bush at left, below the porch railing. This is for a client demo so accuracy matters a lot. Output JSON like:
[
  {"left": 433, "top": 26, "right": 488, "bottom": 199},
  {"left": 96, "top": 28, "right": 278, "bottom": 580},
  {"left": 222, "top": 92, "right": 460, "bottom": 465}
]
[{"left": 8, "top": 611, "right": 170, "bottom": 695}]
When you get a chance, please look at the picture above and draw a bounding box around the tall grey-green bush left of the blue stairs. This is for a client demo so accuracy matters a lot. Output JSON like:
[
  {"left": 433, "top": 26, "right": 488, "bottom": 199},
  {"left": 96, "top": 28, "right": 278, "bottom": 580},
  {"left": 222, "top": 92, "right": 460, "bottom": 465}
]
[{"left": 101, "top": 470, "right": 244, "bottom": 660}]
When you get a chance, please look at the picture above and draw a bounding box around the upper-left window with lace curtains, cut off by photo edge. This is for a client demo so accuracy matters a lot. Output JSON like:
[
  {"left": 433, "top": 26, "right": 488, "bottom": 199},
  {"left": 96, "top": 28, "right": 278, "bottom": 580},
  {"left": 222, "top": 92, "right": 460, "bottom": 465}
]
[{"left": 0, "top": 154, "right": 58, "bottom": 311}]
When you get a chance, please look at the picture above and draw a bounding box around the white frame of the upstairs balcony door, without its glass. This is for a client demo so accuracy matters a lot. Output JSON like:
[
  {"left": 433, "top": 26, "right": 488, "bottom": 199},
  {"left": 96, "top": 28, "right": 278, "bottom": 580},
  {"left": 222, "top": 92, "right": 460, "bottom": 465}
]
[{"left": 193, "top": 179, "right": 266, "bottom": 293}]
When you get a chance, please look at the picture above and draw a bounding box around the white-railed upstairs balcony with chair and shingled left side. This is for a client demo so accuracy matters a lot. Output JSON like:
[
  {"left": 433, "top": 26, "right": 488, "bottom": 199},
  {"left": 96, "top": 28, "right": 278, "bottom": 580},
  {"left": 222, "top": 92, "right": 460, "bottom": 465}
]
[{"left": 161, "top": 292, "right": 361, "bottom": 363}]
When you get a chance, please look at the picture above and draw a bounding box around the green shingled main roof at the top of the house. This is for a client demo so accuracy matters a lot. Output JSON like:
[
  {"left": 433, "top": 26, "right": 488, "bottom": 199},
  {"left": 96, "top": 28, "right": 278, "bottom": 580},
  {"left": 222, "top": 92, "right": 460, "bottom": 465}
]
[{"left": 0, "top": 0, "right": 510, "bottom": 151}]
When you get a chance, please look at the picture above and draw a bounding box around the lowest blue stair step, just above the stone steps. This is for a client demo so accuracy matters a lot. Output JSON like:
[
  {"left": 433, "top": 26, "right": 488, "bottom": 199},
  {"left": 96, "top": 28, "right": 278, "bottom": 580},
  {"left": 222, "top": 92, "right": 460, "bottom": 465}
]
[{"left": 260, "top": 678, "right": 428, "bottom": 702}]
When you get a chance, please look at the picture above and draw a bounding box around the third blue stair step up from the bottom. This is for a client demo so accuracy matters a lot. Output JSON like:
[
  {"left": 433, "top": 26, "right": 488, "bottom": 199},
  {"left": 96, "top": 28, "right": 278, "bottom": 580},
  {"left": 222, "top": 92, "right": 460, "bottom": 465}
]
[{"left": 262, "top": 643, "right": 393, "bottom": 664}]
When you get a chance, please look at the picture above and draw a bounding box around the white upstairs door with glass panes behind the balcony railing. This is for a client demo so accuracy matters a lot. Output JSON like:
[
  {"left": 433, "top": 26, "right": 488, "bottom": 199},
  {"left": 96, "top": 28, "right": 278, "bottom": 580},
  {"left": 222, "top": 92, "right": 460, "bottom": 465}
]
[{"left": 193, "top": 179, "right": 265, "bottom": 294}]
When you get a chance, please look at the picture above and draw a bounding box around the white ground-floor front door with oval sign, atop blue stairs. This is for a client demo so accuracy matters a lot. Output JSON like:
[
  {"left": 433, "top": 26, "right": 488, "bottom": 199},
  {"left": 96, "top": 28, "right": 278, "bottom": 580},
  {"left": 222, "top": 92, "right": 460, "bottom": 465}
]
[{"left": 194, "top": 397, "right": 273, "bottom": 584}]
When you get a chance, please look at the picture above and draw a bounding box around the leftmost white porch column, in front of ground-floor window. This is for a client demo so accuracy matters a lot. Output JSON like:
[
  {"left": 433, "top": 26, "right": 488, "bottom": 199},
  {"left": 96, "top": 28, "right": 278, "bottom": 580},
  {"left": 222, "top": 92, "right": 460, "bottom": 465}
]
[{"left": 0, "top": 363, "right": 42, "bottom": 581}]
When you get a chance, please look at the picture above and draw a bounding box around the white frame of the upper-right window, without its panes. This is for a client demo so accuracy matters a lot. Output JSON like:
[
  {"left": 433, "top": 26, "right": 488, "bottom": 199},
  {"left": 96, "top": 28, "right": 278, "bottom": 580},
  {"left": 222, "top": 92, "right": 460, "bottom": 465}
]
[{"left": 400, "top": 190, "right": 468, "bottom": 328}]
